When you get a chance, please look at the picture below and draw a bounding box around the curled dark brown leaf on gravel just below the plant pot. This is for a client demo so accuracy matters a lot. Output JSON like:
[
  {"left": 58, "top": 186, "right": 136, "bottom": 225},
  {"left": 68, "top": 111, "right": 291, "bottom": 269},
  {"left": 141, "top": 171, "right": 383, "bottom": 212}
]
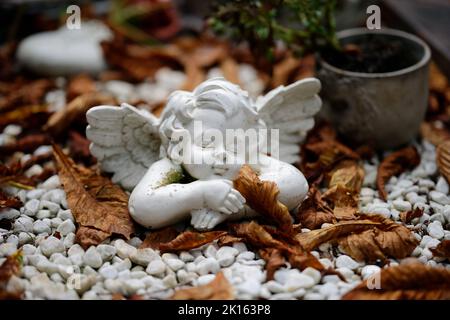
[{"left": 377, "top": 146, "right": 420, "bottom": 200}]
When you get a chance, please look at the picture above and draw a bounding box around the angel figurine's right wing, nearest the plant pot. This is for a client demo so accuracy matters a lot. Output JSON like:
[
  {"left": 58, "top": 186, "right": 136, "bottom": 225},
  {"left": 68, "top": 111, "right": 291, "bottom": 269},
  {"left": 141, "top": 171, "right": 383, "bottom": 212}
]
[{"left": 256, "top": 78, "right": 322, "bottom": 163}]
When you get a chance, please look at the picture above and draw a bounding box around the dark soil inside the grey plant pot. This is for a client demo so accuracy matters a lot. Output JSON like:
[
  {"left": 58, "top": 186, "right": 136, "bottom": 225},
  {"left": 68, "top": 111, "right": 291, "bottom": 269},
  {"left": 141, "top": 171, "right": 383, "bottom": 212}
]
[{"left": 322, "top": 35, "right": 417, "bottom": 73}]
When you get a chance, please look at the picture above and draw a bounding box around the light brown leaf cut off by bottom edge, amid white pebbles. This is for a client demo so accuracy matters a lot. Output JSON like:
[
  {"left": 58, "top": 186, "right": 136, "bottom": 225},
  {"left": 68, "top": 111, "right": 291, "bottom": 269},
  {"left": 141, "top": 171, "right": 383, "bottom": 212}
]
[{"left": 171, "top": 272, "right": 234, "bottom": 300}]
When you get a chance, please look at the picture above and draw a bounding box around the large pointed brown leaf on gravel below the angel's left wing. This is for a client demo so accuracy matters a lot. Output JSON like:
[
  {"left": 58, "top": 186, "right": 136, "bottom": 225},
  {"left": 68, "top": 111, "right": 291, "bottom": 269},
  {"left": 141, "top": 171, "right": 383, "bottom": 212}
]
[{"left": 53, "top": 145, "right": 134, "bottom": 248}]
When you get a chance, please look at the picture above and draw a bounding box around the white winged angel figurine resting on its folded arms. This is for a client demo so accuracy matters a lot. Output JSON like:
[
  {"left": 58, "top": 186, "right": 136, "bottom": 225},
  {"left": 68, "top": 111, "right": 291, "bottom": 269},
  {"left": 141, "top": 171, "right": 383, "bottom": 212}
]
[{"left": 86, "top": 78, "right": 322, "bottom": 230}]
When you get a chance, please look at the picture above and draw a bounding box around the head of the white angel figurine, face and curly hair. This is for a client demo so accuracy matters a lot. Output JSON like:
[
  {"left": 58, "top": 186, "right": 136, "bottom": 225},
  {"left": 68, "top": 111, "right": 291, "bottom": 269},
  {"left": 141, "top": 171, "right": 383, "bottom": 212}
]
[{"left": 160, "top": 78, "right": 264, "bottom": 180}]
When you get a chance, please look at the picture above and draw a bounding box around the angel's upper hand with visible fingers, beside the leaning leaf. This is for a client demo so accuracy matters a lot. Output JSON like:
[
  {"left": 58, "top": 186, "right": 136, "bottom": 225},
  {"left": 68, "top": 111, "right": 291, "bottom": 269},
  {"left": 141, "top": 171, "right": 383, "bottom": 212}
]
[{"left": 202, "top": 179, "right": 245, "bottom": 214}]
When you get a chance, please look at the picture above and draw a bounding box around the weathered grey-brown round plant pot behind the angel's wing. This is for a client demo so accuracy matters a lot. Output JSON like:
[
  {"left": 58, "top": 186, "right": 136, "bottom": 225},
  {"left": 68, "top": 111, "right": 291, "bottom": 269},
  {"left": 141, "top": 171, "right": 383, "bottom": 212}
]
[{"left": 319, "top": 28, "right": 431, "bottom": 149}]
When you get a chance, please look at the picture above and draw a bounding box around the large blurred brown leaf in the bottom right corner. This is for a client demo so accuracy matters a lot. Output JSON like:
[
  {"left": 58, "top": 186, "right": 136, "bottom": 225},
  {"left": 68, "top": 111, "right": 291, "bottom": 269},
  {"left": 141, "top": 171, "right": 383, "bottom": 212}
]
[{"left": 343, "top": 263, "right": 450, "bottom": 300}]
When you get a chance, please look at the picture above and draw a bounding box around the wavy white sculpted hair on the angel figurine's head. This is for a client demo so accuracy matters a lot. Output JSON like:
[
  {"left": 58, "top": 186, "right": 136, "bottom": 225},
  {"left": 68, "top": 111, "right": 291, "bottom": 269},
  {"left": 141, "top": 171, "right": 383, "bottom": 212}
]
[{"left": 159, "top": 78, "right": 258, "bottom": 162}]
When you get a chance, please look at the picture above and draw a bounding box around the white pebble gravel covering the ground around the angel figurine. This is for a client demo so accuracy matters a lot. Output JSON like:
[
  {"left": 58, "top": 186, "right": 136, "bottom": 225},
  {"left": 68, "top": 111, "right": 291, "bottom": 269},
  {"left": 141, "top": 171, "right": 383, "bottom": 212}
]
[{"left": 0, "top": 65, "right": 450, "bottom": 299}]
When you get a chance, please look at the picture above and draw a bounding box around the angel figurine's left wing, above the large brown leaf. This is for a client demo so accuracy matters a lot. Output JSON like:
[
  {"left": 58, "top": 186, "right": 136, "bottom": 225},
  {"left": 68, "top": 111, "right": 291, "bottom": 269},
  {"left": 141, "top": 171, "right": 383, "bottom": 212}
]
[{"left": 86, "top": 103, "right": 161, "bottom": 190}]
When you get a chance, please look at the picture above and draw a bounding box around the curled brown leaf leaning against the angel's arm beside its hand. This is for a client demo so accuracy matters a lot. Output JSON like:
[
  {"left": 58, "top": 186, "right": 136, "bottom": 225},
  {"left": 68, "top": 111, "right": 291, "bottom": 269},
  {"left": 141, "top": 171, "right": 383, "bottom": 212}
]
[{"left": 234, "top": 165, "right": 292, "bottom": 232}]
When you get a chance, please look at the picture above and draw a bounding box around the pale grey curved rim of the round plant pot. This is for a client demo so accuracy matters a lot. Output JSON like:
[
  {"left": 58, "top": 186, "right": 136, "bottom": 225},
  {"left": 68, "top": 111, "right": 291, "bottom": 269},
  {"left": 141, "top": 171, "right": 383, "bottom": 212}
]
[{"left": 321, "top": 28, "right": 431, "bottom": 79}]
